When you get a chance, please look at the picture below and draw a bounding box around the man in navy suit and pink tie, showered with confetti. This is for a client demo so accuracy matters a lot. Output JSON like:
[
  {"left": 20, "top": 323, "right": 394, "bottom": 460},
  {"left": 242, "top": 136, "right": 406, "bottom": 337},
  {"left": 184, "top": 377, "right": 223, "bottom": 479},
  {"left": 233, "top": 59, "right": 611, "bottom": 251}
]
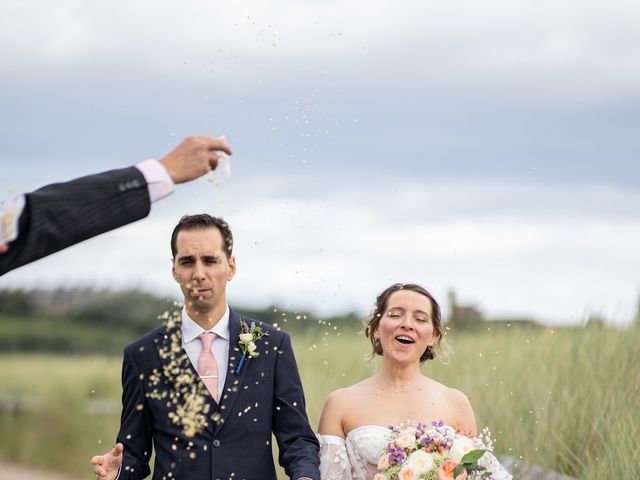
[{"left": 91, "top": 214, "right": 320, "bottom": 480}]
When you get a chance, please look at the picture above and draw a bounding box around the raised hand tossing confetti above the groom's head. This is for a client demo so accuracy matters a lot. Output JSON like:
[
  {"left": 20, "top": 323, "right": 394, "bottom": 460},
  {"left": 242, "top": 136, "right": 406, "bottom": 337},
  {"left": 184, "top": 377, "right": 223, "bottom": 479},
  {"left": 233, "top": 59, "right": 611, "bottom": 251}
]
[{"left": 160, "top": 136, "right": 233, "bottom": 183}]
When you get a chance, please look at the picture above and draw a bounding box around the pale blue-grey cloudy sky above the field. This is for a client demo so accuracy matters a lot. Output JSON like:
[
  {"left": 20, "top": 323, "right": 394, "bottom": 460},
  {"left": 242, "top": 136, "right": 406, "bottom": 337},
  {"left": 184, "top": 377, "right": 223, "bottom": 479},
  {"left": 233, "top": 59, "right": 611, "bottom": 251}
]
[{"left": 0, "top": 0, "right": 640, "bottom": 324}]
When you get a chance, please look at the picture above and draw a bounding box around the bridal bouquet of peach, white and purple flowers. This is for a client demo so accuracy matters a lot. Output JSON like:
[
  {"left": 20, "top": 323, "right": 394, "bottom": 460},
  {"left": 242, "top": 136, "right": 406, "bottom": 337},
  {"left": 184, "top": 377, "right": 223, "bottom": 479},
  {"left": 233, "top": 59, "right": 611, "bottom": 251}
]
[{"left": 374, "top": 421, "right": 511, "bottom": 480}]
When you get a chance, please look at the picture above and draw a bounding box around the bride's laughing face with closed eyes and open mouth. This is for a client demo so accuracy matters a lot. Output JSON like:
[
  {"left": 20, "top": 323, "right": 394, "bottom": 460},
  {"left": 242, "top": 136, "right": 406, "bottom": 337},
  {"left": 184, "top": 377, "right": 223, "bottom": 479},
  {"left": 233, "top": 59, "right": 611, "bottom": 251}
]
[{"left": 374, "top": 290, "right": 437, "bottom": 363}]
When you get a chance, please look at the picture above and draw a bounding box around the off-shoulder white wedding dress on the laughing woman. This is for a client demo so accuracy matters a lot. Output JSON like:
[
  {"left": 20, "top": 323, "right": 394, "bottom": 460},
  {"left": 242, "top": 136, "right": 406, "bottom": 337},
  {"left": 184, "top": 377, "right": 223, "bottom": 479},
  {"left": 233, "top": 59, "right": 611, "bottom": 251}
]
[{"left": 318, "top": 425, "right": 511, "bottom": 480}]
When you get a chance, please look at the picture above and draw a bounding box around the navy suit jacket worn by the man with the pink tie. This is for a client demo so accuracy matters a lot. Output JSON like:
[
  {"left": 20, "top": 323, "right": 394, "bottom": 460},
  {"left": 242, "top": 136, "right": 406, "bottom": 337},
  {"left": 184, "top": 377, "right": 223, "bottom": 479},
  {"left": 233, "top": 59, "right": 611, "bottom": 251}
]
[{"left": 118, "top": 311, "right": 320, "bottom": 480}]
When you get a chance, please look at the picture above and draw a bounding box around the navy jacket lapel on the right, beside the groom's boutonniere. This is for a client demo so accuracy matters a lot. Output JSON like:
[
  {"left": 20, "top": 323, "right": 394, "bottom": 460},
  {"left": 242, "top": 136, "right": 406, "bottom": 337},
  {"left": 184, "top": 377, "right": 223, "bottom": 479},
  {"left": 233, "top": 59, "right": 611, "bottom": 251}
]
[{"left": 214, "top": 309, "right": 249, "bottom": 434}]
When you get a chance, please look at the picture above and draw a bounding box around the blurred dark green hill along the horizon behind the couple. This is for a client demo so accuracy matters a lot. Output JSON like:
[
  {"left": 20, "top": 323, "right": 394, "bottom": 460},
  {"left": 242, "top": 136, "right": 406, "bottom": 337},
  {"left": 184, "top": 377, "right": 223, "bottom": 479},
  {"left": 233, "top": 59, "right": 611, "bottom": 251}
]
[{"left": 0, "top": 289, "right": 556, "bottom": 354}]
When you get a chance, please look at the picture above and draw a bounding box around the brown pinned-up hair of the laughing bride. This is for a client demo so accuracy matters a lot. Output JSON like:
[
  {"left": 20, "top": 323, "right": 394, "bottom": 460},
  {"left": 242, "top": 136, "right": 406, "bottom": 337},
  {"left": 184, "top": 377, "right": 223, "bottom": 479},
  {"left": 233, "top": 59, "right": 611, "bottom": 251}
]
[{"left": 364, "top": 283, "right": 443, "bottom": 363}]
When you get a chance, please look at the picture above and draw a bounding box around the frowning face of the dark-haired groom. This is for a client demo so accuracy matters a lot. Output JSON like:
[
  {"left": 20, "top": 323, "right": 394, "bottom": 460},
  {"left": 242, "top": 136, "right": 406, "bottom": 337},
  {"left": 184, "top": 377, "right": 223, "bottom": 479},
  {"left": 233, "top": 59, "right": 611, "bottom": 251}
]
[{"left": 172, "top": 227, "right": 236, "bottom": 313}]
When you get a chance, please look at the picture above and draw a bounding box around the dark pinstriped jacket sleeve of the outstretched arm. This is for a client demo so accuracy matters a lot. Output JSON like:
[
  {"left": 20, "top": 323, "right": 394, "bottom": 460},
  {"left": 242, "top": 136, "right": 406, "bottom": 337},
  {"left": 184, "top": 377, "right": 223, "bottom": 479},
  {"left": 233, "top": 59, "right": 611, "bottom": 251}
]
[{"left": 0, "top": 167, "right": 151, "bottom": 275}]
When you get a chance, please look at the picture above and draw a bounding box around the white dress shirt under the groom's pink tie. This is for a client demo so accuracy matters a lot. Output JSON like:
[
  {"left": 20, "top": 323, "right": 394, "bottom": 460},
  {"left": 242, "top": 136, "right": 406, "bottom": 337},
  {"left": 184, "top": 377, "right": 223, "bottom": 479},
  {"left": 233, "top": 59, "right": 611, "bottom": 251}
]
[{"left": 182, "top": 305, "right": 229, "bottom": 398}]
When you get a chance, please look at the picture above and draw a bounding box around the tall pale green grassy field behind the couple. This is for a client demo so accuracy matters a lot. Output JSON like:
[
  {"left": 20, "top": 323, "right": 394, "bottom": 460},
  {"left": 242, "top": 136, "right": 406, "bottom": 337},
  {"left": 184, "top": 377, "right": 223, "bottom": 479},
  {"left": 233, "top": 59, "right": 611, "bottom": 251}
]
[{"left": 0, "top": 326, "right": 640, "bottom": 479}]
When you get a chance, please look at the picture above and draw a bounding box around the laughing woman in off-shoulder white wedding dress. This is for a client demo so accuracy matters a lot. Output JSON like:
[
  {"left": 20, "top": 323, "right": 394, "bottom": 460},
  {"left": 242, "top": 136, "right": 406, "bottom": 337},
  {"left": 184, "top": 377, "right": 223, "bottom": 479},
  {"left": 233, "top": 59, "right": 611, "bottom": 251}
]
[{"left": 318, "top": 284, "right": 510, "bottom": 480}]
